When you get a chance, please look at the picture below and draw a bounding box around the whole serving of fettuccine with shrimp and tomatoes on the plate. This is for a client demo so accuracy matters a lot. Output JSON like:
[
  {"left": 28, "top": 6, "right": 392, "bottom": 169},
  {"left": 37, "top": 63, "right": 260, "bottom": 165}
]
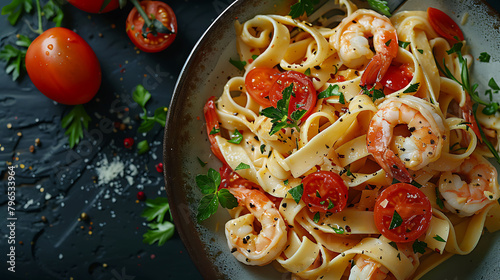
[{"left": 199, "top": 1, "right": 500, "bottom": 280}]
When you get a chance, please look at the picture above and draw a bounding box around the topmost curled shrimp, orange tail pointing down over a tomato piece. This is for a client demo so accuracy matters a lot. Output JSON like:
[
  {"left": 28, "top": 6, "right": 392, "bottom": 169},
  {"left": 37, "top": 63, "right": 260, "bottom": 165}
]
[{"left": 330, "top": 9, "right": 398, "bottom": 86}]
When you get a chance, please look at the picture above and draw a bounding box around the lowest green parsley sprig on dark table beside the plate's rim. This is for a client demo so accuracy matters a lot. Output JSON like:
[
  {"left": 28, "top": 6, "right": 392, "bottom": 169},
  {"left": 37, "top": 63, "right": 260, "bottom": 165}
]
[{"left": 141, "top": 197, "right": 175, "bottom": 246}]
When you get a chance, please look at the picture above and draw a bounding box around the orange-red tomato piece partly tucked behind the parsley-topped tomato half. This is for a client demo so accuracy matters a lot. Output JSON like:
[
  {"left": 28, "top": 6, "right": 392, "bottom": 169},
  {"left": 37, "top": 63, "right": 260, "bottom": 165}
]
[{"left": 245, "top": 68, "right": 280, "bottom": 107}]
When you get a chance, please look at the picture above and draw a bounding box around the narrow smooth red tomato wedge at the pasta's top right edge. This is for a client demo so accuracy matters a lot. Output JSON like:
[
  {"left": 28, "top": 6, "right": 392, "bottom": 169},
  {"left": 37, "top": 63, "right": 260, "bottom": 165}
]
[{"left": 427, "top": 7, "right": 464, "bottom": 41}]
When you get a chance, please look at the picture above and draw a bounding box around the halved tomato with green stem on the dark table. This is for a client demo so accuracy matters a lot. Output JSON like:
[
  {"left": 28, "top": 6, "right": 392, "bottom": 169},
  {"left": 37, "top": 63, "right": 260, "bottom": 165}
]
[{"left": 126, "top": 1, "right": 177, "bottom": 52}]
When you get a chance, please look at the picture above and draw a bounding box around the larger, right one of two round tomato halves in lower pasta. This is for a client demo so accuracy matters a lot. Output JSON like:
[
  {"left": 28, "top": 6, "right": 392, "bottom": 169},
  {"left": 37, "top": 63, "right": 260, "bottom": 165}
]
[{"left": 374, "top": 183, "right": 432, "bottom": 242}]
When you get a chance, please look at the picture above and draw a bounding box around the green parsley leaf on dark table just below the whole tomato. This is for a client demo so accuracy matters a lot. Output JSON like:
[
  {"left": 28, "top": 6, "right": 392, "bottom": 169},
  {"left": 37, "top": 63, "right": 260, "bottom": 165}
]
[{"left": 61, "top": 105, "right": 91, "bottom": 149}]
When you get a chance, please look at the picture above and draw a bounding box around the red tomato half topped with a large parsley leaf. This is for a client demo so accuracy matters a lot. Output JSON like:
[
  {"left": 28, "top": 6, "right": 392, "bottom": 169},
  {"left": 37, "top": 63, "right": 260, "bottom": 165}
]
[{"left": 269, "top": 71, "right": 317, "bottom": 119}]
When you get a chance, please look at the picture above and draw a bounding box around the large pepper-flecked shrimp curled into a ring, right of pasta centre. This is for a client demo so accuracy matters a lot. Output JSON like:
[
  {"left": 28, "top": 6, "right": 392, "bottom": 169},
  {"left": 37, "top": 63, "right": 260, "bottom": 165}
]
[{"left": 366, "top": 95, "right": 445, "bottom": 183}]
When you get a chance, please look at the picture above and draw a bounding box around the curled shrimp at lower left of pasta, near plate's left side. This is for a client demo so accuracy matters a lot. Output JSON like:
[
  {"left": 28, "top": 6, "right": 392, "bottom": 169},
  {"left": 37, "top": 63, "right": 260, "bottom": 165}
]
[{"left": 226, "top": 188, "right": 287, "bottom": 265}]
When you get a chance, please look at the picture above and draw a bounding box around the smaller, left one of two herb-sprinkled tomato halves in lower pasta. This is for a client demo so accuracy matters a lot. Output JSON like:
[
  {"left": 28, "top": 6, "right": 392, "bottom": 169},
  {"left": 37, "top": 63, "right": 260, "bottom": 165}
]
[{"left": 302, "top": 171, "right": 348, "bottom": 213}]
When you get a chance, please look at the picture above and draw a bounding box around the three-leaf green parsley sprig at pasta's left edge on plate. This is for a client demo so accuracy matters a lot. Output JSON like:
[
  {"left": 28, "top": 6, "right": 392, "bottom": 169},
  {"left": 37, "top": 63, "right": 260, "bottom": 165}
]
[{"left": 196, "top": 168, "right": 238, "bottom": 222}]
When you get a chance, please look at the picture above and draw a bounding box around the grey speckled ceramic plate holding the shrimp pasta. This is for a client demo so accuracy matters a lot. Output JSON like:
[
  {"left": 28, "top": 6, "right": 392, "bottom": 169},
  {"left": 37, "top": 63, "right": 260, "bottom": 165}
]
[{"left": 164, "top": 0, "right": 500, "bottom": 280}]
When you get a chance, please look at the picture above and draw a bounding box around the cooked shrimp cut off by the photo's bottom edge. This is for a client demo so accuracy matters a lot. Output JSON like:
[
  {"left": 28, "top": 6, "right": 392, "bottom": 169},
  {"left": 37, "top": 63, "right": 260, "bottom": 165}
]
[{"left": 349, "top": 255, "right": 389, "bottom": 280}]
